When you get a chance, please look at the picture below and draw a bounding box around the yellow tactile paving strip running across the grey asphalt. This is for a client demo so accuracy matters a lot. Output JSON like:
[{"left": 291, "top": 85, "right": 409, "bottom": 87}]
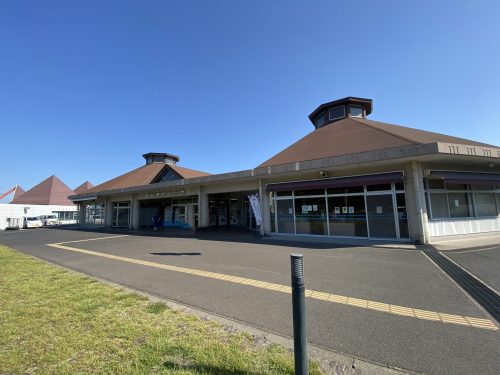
[{"left": 47, "top": 241, "right": 498, "bottom": 331}]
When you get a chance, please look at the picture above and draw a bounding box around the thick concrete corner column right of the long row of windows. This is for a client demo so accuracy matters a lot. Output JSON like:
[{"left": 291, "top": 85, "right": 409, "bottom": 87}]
[{"left": 405, "top": 161, "right": 430, "bottom": 244}]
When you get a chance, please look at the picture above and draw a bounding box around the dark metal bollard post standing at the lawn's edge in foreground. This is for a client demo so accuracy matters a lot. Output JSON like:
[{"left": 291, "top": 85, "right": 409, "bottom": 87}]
[{"left": 290, "top": 254, "right": 309, "bottom": 375}]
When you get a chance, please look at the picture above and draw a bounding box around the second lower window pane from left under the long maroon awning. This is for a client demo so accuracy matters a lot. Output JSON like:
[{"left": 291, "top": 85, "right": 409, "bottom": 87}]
[{"left": 295, "top": 197, "right": 328, "bottom": 235}]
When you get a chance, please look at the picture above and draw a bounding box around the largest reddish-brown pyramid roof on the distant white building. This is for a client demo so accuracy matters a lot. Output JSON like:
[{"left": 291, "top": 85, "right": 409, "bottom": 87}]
[{"left": 10, "top": 176, "right": 74, "bottom": 206}]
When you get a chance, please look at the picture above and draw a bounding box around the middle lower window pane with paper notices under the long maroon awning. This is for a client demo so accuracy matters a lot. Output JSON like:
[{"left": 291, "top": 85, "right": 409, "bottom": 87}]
[{"left": 328, "top": 195, "right": 368, "bottom": 237}]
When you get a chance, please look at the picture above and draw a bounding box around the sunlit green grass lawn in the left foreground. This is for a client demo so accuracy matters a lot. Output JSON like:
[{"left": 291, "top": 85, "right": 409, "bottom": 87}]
[{"left": 0, "top": 246, "right": 321, "bottom": 374}]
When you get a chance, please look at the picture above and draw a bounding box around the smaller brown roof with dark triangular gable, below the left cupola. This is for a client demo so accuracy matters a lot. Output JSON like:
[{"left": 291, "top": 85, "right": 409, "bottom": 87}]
[{"left": 85, "top": 163, "right": 209, "bottom": 194}]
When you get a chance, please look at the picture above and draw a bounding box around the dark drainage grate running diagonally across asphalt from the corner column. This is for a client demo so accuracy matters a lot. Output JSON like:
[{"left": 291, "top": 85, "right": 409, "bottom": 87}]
[{"left": 423, "top": 246, "right": 500, "bottom": 323}]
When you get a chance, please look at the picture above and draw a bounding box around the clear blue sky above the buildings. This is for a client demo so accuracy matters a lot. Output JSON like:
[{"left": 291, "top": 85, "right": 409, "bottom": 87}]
[{"left": 0, "top": 0, "right": 500, "bottom": 203}]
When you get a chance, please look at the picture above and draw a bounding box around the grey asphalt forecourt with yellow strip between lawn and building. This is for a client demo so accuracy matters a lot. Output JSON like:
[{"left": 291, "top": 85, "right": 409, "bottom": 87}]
[{"left": 0, "top": 229, "right": 500, "bottom": 374}]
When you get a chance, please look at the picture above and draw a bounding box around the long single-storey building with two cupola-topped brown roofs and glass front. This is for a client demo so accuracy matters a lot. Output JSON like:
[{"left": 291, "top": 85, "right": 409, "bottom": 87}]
[{"left": 70, "top": 97, "right": 500, "bottom": 243}]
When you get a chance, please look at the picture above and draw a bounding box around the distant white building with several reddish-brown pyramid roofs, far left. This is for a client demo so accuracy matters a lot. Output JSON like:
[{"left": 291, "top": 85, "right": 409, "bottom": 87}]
[{"left": 0, "top": 176, "right": 92, "bottom": 230}]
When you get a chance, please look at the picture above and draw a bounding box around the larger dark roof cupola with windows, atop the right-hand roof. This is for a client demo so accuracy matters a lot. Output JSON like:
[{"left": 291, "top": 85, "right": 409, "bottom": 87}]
[{"left": 309, "top": 96, "right": 373, "bottom": 129}]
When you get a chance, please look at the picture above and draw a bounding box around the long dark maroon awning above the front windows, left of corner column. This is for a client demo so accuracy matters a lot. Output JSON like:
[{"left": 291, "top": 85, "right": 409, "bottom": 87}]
[{"left": 267, "top": 172, "right": 403, "bottom": 191}]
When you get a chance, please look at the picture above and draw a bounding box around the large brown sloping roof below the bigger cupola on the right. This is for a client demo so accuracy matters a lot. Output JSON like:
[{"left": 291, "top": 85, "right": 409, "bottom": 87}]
[{"left": 258, "top": 117, "right": 496, "bottom": 168}]
